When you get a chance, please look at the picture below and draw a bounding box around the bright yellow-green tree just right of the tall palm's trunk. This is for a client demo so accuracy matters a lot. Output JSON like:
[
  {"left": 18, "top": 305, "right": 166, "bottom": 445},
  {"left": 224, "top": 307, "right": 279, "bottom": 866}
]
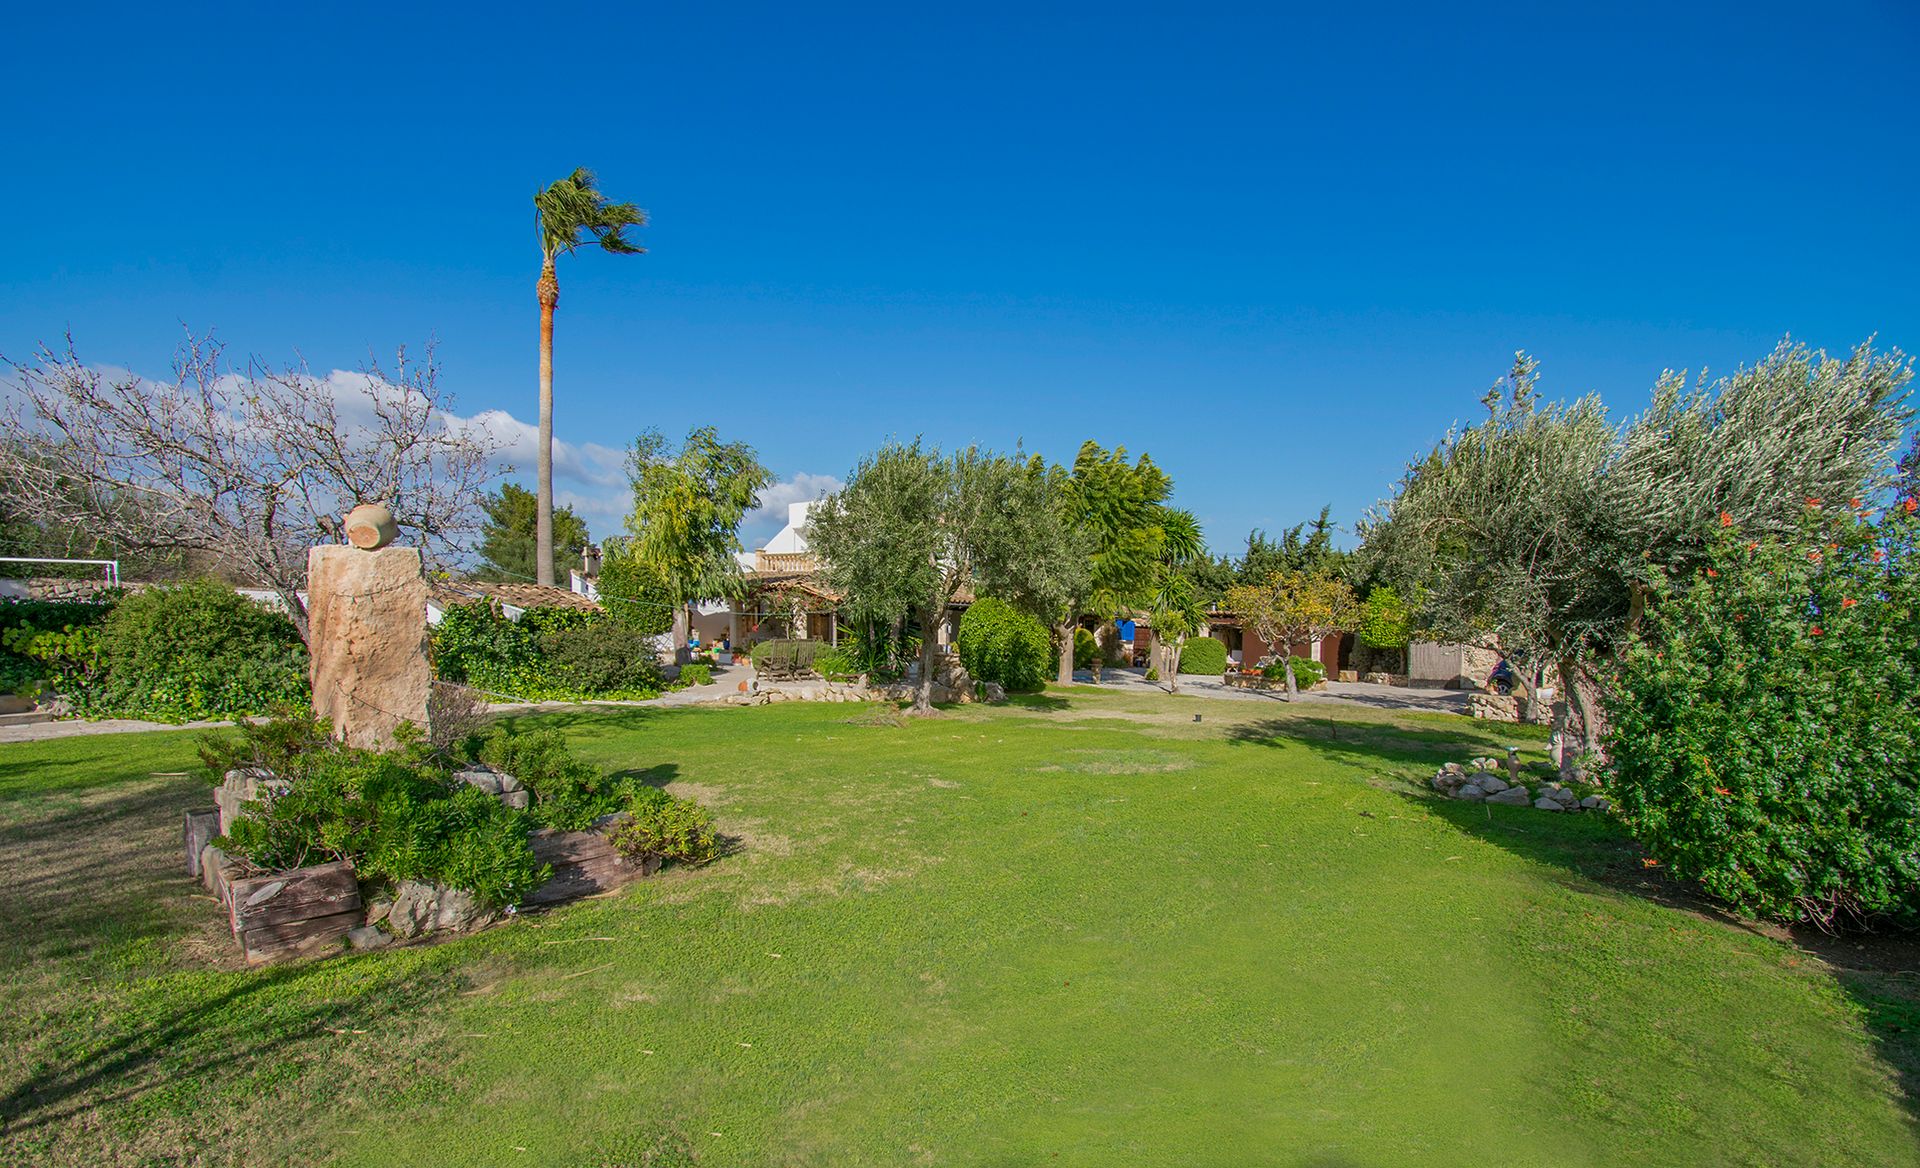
[{"left": 620, "top": 426, "right": 774, "bottom": 633}]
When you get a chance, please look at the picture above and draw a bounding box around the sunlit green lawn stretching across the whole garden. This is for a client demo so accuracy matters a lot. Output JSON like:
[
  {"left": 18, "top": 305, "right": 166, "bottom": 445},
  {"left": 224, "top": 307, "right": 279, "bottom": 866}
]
[{"left": 0, "top": 690, "right": 1920, "bottom": 1168}]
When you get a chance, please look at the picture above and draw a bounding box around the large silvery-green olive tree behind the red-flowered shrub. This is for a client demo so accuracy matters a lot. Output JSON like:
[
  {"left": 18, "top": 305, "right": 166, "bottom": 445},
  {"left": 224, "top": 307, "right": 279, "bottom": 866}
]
[{"left": 1361, "top": 342, "right": 1912, "bottom": 751}]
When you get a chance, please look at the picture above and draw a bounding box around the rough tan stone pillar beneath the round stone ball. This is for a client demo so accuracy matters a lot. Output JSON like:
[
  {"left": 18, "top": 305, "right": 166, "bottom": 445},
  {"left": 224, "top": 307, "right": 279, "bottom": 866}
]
[{"left": 307, "top": 546, "right": 434, "bottom": 749}]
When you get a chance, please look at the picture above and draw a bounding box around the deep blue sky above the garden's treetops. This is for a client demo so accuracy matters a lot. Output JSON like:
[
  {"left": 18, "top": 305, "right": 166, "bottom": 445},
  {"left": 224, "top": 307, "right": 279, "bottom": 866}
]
[{"left": 0, "top": 2, "right": 1920, "bottom": 551}]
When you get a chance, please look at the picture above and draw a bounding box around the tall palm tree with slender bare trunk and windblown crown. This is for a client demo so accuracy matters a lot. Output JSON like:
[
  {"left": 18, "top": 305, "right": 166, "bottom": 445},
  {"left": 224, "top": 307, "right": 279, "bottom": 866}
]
[{"left": 534, "top": 169, "right": 647, "bottom": 584}]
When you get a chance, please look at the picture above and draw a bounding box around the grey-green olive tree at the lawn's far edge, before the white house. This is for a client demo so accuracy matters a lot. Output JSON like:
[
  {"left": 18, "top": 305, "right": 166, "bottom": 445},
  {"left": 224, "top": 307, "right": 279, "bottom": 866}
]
[{"left": 806, "top": 440, "right": 1058, "bottom": 715}]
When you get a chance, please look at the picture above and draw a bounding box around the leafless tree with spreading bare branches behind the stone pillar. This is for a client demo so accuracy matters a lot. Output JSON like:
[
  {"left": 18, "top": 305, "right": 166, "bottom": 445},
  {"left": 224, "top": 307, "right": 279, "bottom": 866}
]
[{"left": 0, "top": 334, "right": 499, "bottom": 636}]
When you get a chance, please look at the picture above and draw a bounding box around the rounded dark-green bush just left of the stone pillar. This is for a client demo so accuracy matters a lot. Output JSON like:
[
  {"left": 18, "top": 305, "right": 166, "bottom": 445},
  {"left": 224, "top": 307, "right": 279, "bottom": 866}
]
[{"left": 53, "top": 580, "right": 307, "bottom": 722}]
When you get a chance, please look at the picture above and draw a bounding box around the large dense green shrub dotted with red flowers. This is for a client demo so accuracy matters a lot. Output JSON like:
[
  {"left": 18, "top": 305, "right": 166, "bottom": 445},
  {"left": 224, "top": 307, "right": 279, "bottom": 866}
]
[{"left": 1605, "top": 501, "right": 1920, "bottom": 924}]
